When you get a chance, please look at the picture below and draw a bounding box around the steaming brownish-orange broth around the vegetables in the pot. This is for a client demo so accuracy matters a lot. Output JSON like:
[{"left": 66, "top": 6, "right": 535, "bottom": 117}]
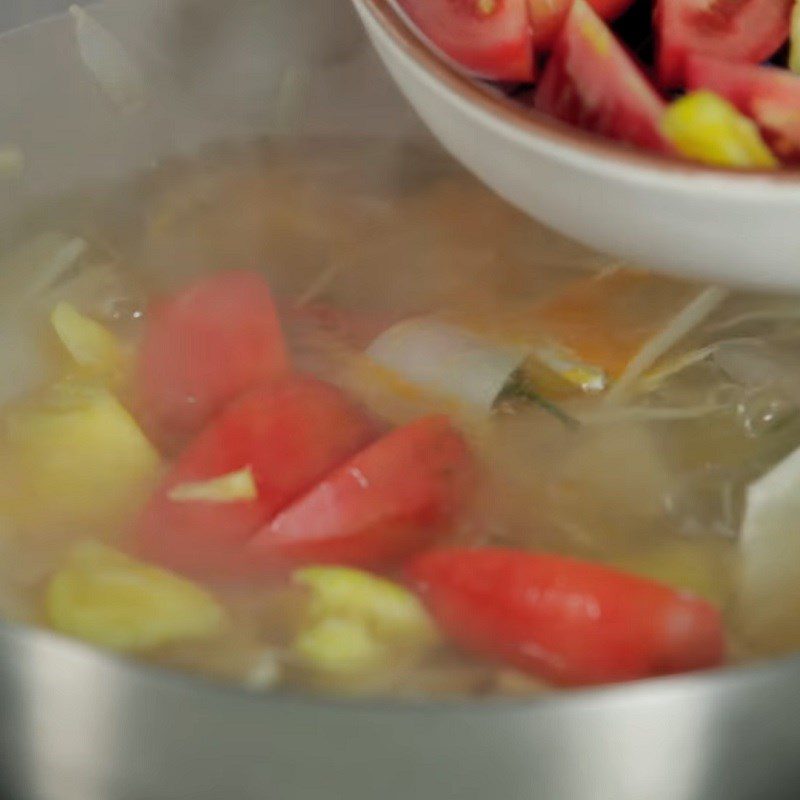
[{"left": 0, "top": 140, "right": 800, "bottom": 697}]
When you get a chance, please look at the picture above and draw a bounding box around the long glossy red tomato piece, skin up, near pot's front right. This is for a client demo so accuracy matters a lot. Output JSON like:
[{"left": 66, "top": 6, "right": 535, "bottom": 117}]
[{"left": 407, "top": 549, "right": 724, "bottom": 686}]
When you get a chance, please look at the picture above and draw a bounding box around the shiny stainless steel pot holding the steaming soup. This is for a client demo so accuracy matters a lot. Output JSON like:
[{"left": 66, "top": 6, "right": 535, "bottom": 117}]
[{"left": 0, "top": 0, "right": 800, "bottom": 800}]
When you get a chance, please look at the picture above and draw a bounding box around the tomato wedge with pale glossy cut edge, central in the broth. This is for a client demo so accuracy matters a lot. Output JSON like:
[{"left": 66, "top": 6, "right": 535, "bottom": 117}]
[{"left": 248, "top": 416, "right": 474, "bottom": 568}]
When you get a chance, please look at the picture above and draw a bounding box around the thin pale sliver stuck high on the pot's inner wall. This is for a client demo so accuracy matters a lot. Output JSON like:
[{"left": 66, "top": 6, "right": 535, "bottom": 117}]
[{"left": 69, "top": 5, "right": 147, "bottom": 113}]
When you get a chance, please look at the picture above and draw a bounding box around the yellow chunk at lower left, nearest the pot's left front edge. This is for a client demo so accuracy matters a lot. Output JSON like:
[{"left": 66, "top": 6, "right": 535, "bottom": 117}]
[{"left": 45, "top": 542, "right": 224, "bottom": 653}]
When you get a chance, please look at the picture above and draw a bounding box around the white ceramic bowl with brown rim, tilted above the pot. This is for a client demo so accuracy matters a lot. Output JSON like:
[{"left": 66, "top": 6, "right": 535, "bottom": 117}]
[{"left": 353, "top": 0, "right": 800, "bottom": 290}]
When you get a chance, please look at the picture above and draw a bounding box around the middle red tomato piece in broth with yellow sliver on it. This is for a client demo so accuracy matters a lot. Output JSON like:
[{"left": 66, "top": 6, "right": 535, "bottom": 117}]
[{"left": 137, "top": 376, "right": 377, "bottom": 575}]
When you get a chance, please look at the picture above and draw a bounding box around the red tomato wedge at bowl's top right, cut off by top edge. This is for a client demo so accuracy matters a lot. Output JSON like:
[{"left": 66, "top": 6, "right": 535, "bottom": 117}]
[{"left": 654, "top": 0, "right": 794, "bottom": 89}]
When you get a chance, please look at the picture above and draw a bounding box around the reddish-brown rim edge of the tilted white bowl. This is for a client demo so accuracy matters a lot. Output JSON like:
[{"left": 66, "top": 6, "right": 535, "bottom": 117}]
[{"left": 354, "top": 0, "right": 800, "bottom": 189}]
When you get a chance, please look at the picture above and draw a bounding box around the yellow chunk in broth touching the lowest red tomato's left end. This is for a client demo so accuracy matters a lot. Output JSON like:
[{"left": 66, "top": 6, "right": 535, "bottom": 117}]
[{"left": 294, "top": 567, "right": 437, "bottom": 678}]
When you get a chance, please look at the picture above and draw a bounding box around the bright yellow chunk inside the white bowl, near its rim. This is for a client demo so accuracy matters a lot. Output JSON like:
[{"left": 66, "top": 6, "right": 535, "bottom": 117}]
[{"left": 661, "top": 90, "right": 778, "bottom": 168}]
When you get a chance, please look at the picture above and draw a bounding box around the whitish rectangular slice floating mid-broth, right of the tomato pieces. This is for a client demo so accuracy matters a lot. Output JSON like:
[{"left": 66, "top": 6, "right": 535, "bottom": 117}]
[{"left": 367, "top": 317, "right": 529, "bottom": 411}]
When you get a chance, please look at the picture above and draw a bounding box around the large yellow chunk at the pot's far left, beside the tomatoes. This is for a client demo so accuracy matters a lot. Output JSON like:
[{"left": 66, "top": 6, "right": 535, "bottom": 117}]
[{"left": 6, "top": 379, "right": 160, "bottom": 528}]
